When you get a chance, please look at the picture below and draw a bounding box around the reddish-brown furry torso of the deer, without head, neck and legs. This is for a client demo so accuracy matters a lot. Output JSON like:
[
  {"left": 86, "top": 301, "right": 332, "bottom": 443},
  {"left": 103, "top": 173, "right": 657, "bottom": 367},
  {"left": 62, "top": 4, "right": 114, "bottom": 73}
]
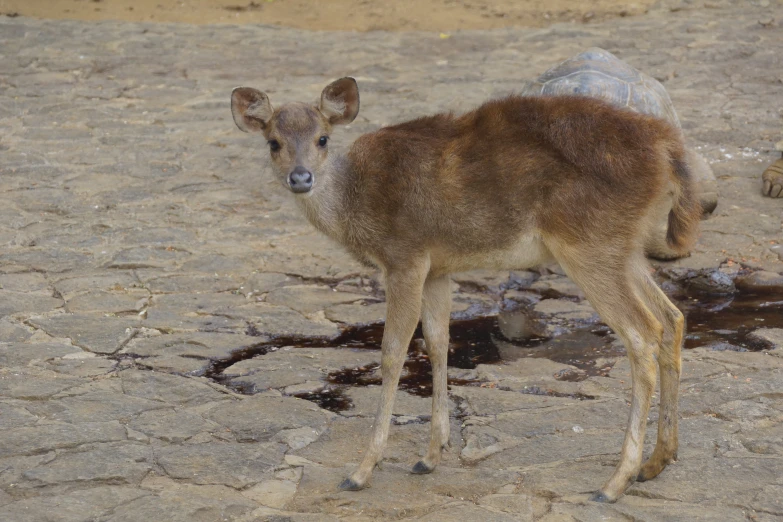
[{"left": 350, "top": 97, "right": 682, "bottom": 270}]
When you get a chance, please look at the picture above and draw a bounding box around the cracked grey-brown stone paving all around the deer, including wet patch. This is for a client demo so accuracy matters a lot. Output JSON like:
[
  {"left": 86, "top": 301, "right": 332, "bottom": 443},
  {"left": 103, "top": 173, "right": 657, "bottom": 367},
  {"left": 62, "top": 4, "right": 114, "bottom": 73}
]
[{"left": 0, "top": 1, "right": 783, "bottom": 522}]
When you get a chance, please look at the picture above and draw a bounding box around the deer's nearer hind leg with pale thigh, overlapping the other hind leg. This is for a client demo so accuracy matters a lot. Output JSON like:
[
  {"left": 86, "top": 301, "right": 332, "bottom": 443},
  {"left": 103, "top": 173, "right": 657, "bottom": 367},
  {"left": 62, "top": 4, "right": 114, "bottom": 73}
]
[{"left": 550, "top": 244, "right": 663, "bottom": 502}]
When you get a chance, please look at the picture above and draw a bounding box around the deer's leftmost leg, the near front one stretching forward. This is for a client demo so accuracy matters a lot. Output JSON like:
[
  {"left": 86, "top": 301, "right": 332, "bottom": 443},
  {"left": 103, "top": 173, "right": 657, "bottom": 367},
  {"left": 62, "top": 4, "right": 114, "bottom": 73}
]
[{"left": 340, "top": 262, "right": 429, "bottom": 491}]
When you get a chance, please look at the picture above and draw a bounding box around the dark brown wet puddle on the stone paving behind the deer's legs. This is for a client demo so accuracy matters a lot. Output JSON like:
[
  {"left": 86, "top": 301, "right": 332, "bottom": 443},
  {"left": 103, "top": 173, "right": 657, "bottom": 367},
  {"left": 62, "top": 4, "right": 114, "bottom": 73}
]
[{"left": 207, "top": 284, "right": 783, "bottom": 411}]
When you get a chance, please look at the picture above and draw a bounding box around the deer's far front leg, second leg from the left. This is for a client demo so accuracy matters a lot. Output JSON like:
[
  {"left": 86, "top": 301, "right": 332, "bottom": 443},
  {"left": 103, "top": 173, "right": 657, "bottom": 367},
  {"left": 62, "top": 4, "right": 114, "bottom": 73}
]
[{"left": 412, "top": 275, "right": 451, "bottom": 473}]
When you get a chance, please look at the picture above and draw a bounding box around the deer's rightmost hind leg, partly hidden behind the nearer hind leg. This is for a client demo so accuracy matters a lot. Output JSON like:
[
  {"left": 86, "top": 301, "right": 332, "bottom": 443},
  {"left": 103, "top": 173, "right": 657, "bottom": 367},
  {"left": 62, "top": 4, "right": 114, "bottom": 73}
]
[{"left": 637, "top": 264, "right": 685, "bottom": 482}]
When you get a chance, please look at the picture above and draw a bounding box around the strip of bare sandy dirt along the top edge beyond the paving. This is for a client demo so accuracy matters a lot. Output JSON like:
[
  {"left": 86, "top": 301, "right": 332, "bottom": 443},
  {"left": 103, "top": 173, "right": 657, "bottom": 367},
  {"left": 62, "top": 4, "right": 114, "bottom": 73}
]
[{"left": 0, "top": 0, "right": 654, "bottom": 31}]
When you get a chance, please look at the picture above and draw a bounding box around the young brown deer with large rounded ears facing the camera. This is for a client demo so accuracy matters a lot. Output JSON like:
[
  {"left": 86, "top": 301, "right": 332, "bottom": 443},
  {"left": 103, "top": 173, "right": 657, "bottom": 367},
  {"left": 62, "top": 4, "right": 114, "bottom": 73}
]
[{"left": 231, "top": 78, "right": 701, "bottom": 502}]
